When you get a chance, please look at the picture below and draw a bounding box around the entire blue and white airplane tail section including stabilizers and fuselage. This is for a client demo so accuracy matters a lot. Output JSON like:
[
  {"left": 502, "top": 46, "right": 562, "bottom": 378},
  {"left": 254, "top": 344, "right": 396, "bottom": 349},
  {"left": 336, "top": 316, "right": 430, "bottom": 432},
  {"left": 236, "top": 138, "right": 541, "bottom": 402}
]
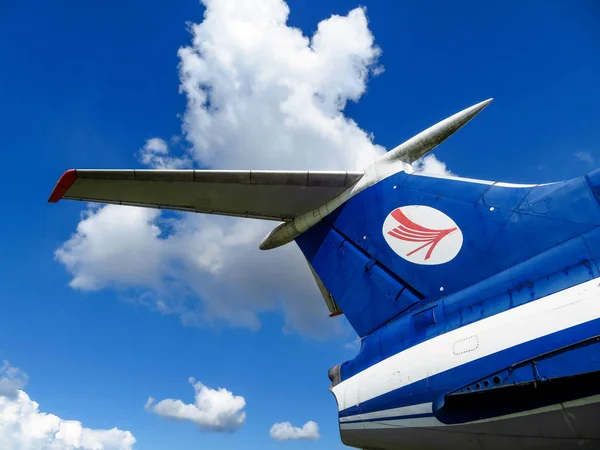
[{"left": 50, "top": 99, "right": 600, "bottom": 450}]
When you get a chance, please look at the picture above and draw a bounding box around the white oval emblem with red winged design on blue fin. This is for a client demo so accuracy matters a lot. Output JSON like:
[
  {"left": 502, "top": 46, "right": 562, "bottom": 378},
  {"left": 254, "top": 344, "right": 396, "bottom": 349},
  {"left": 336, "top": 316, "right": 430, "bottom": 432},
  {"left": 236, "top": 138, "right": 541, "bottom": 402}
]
[{"left": 383, "top": 205, "right": 463, "bottom": 265}]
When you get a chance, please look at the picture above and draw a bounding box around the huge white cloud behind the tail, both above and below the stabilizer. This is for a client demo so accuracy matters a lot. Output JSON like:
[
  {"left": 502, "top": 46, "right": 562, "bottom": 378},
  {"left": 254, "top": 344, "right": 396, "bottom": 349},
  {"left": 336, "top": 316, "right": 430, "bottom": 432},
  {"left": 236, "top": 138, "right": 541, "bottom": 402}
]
[{"left": 56, "top": 0, "right": 450, "bottom": 335}]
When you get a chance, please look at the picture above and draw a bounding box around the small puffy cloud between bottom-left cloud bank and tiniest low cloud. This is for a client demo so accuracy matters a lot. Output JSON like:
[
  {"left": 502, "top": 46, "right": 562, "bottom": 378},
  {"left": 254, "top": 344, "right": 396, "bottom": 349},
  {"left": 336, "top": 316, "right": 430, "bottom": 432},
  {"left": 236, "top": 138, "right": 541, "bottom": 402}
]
[{"left": 145, "top": 378, "right": 246, "bottom": 432}]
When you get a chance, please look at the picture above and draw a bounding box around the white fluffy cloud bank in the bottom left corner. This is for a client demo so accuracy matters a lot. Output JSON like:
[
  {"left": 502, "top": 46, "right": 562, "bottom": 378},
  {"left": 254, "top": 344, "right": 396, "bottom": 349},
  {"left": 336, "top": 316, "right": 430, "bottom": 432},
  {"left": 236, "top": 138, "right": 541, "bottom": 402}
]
[{"left": 0, "top": 361, "right": 135, "bottom": 450}]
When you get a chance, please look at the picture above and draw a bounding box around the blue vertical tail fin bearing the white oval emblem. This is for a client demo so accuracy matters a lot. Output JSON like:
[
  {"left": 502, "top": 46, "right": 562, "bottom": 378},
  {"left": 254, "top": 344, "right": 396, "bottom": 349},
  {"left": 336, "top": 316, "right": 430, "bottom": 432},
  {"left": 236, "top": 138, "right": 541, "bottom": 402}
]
[{"left": 296, "top": 170, "right": 600, "bottom": 337}]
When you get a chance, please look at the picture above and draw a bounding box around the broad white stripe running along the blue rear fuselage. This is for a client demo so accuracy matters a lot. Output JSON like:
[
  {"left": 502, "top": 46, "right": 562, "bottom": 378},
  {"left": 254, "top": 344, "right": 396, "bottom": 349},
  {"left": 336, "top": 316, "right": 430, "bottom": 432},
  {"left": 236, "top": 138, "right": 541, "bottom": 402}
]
[{"left": 332, "top": 278, "right": 600, "bottom": 411}]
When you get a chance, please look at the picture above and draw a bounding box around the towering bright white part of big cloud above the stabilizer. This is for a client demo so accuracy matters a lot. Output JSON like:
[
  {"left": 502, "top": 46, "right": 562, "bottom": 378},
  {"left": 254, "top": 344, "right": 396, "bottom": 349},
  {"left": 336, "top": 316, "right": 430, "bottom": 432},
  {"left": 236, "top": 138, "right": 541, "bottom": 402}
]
[{"left": 179, "top": 0, "right": 383, "bottom": 169}]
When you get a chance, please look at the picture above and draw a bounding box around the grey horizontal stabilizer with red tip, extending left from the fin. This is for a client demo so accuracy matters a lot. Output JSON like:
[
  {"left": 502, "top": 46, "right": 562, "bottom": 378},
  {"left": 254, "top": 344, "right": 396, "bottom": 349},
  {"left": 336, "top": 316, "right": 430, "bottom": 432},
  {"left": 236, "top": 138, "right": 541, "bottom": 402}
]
[{"left": 48, "top": 169, "right": 363, "bottom": 221}]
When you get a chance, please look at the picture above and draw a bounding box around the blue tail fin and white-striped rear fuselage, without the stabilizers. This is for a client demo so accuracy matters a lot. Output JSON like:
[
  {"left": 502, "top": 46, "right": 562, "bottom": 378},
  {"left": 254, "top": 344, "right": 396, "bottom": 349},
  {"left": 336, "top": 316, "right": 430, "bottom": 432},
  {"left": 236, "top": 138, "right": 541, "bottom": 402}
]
[{"left": 296, "top": 170, "right": 600, "bottom": 449}]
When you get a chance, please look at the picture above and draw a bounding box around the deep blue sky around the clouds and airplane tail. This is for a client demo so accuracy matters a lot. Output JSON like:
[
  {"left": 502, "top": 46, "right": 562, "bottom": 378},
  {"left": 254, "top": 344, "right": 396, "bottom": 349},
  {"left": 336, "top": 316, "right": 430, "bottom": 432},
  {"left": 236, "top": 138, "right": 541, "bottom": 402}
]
[{"left": 0, "top": 0, "right": 600, "bottom": 449}]
